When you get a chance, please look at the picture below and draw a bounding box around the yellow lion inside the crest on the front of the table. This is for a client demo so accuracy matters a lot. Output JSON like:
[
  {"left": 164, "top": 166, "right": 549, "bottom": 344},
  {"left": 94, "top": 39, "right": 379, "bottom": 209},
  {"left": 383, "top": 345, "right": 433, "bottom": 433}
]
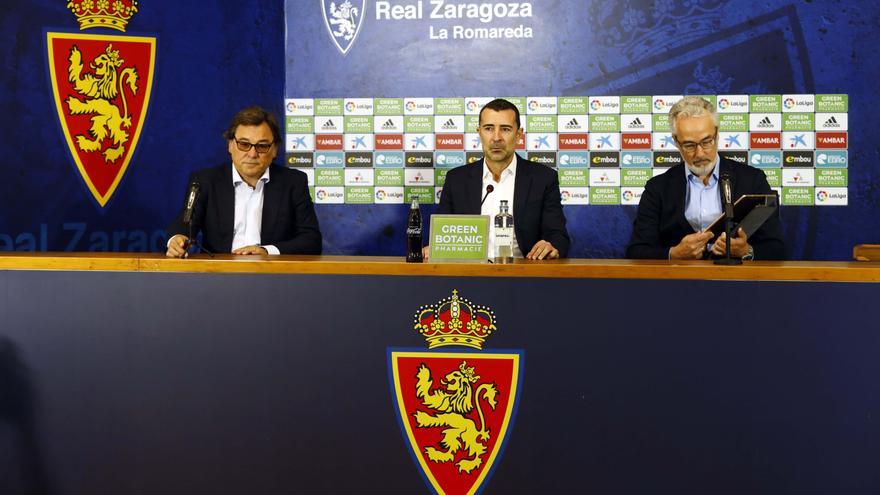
[{"left": 413, "top": 361, "right": 498, "bottom": 474}]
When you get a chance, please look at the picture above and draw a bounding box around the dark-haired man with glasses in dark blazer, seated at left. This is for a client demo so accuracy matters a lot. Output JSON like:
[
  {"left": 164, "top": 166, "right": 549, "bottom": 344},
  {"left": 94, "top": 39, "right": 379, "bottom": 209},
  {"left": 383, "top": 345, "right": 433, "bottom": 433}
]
[{"left": 165, "top": 107, "right": 321, "bottom": 258}]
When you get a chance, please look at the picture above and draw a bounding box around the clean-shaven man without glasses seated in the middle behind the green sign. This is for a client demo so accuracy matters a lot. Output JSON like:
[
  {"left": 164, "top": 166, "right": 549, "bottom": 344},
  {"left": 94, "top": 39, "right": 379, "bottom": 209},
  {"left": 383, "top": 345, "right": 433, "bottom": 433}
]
[{"left": 425, "top": 99, "right": 570, "bottom": 260}]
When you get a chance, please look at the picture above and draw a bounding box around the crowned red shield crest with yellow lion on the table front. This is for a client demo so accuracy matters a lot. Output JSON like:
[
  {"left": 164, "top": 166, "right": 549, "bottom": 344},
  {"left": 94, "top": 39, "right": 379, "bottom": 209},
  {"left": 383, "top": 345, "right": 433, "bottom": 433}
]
[{"left": 388, "top": 291, "right": 523, "bottom": 495}]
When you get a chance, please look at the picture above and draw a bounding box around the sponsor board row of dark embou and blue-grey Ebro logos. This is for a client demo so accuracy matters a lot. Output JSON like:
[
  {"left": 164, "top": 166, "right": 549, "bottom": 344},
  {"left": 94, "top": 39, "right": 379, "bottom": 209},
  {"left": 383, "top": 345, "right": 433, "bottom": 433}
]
[{"left": 285, "top": 150, "right": 849, "bottom": 169}]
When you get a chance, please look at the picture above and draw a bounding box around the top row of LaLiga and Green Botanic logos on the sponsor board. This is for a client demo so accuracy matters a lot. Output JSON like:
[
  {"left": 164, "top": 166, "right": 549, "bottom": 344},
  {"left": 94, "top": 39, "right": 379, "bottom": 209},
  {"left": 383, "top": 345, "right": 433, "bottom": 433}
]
[{"left": 284, "top": 94, "right": 849, "bottom": 116}]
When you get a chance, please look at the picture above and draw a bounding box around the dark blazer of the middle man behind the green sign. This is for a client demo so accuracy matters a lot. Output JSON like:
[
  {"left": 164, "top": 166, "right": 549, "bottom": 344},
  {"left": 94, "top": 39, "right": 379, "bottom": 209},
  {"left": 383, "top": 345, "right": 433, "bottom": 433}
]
[{"left": 437, "top": 155, "right": 571, "bottom": 258}]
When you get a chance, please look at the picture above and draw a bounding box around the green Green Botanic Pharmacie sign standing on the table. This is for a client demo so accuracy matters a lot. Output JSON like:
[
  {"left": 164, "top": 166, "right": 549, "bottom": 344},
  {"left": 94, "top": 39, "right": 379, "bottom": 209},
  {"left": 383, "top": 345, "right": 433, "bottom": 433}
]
[{"left": 428, "top": 215, "right": 489, "bottom": 262}]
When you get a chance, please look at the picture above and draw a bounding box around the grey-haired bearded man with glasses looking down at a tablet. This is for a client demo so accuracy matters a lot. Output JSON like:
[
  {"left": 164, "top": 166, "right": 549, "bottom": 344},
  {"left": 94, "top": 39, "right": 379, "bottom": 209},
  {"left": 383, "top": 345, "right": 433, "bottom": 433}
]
[{"left": 626, "top": 96, "right": 785, "bottom": 260}]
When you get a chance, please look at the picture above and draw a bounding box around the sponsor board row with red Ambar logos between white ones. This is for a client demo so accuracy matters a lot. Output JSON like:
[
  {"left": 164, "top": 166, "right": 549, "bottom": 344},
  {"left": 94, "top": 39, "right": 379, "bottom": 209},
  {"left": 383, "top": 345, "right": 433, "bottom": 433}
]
[{"left": 285, "top": 131, "right": 849, "bottom": 152}]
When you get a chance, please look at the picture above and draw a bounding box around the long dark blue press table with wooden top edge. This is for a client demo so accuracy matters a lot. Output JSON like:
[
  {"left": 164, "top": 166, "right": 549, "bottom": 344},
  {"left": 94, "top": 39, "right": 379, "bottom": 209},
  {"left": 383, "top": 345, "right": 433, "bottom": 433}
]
[{"left": 0, "top": 253, "right": 880, "bottom": 494}]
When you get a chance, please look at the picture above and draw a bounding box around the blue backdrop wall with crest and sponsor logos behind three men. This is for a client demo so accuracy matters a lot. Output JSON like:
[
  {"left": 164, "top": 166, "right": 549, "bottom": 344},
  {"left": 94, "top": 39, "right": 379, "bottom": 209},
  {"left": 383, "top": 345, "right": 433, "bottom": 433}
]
[{"left": 0, "top": 0, "right": 880, "bottom": 259}]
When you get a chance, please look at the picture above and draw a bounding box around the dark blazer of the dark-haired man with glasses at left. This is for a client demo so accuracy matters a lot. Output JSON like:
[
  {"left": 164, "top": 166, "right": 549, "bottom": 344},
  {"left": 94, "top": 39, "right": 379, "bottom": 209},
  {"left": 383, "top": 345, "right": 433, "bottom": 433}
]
[{"left": 167, "top": 163, "right": 321, "bottom": 254}]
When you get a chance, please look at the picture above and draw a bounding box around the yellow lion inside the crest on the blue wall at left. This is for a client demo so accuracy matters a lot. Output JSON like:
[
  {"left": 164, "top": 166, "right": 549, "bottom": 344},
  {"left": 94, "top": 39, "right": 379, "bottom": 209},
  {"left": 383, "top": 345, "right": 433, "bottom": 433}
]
[{"left": 67, "top": 44, "right": 138, "bottom": 162}]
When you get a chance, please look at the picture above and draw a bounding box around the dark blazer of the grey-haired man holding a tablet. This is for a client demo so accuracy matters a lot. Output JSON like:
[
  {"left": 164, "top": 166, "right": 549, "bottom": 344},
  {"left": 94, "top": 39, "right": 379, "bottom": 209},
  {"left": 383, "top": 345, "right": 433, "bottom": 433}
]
[{"left": 626, "top": 158, "right": 785, "bottom": 260}]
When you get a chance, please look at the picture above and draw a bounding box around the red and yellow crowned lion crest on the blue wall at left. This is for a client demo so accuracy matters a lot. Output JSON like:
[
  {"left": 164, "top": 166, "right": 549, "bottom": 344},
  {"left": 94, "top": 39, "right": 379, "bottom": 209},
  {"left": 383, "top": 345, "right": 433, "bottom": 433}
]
[{"left": 46, "top": 0, "right": 156, "bottom": 207}]
